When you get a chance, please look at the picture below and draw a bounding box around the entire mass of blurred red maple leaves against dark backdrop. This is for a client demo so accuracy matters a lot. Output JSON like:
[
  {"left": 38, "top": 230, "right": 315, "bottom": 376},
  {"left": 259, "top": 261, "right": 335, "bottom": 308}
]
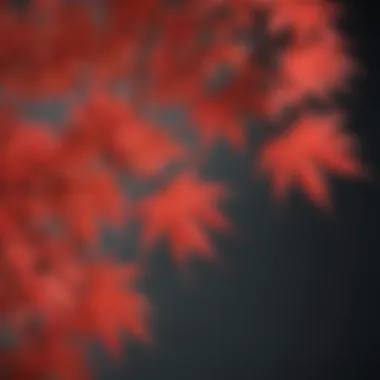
[{"left": 0, "top": 0, "right": 364, "bottom": 380}]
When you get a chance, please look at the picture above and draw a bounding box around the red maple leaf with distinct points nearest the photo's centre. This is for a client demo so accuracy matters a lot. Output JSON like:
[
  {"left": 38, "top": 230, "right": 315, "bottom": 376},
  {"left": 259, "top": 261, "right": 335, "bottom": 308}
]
[{"left": 139, "top": 173, "right": 229, "bottom": 266}]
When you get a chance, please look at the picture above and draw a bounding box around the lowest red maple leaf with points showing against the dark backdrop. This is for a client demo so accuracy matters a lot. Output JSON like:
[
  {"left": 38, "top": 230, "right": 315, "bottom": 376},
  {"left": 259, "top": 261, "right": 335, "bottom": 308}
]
[{"left": 78, "top": 262, "right": 149, "bottom": 354}]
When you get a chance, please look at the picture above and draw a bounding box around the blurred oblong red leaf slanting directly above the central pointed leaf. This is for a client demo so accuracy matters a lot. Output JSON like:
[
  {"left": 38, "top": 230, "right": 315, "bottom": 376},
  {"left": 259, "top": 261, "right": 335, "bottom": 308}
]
[{"left": 73, "top": 93, "right": 185, "bottom": 177}]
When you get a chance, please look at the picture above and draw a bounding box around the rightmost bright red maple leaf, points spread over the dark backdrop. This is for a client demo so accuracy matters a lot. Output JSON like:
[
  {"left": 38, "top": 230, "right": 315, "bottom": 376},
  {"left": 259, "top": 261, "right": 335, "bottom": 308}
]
[{"left": 260, "top": 114, "right": 364, "bottom": 207}]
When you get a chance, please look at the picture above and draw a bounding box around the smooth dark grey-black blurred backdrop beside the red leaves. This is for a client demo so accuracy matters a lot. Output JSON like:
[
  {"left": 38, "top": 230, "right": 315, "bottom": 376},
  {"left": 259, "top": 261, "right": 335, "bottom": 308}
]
[{"left": 84, "top": 1, "right": 380, "bottom": 380}]
